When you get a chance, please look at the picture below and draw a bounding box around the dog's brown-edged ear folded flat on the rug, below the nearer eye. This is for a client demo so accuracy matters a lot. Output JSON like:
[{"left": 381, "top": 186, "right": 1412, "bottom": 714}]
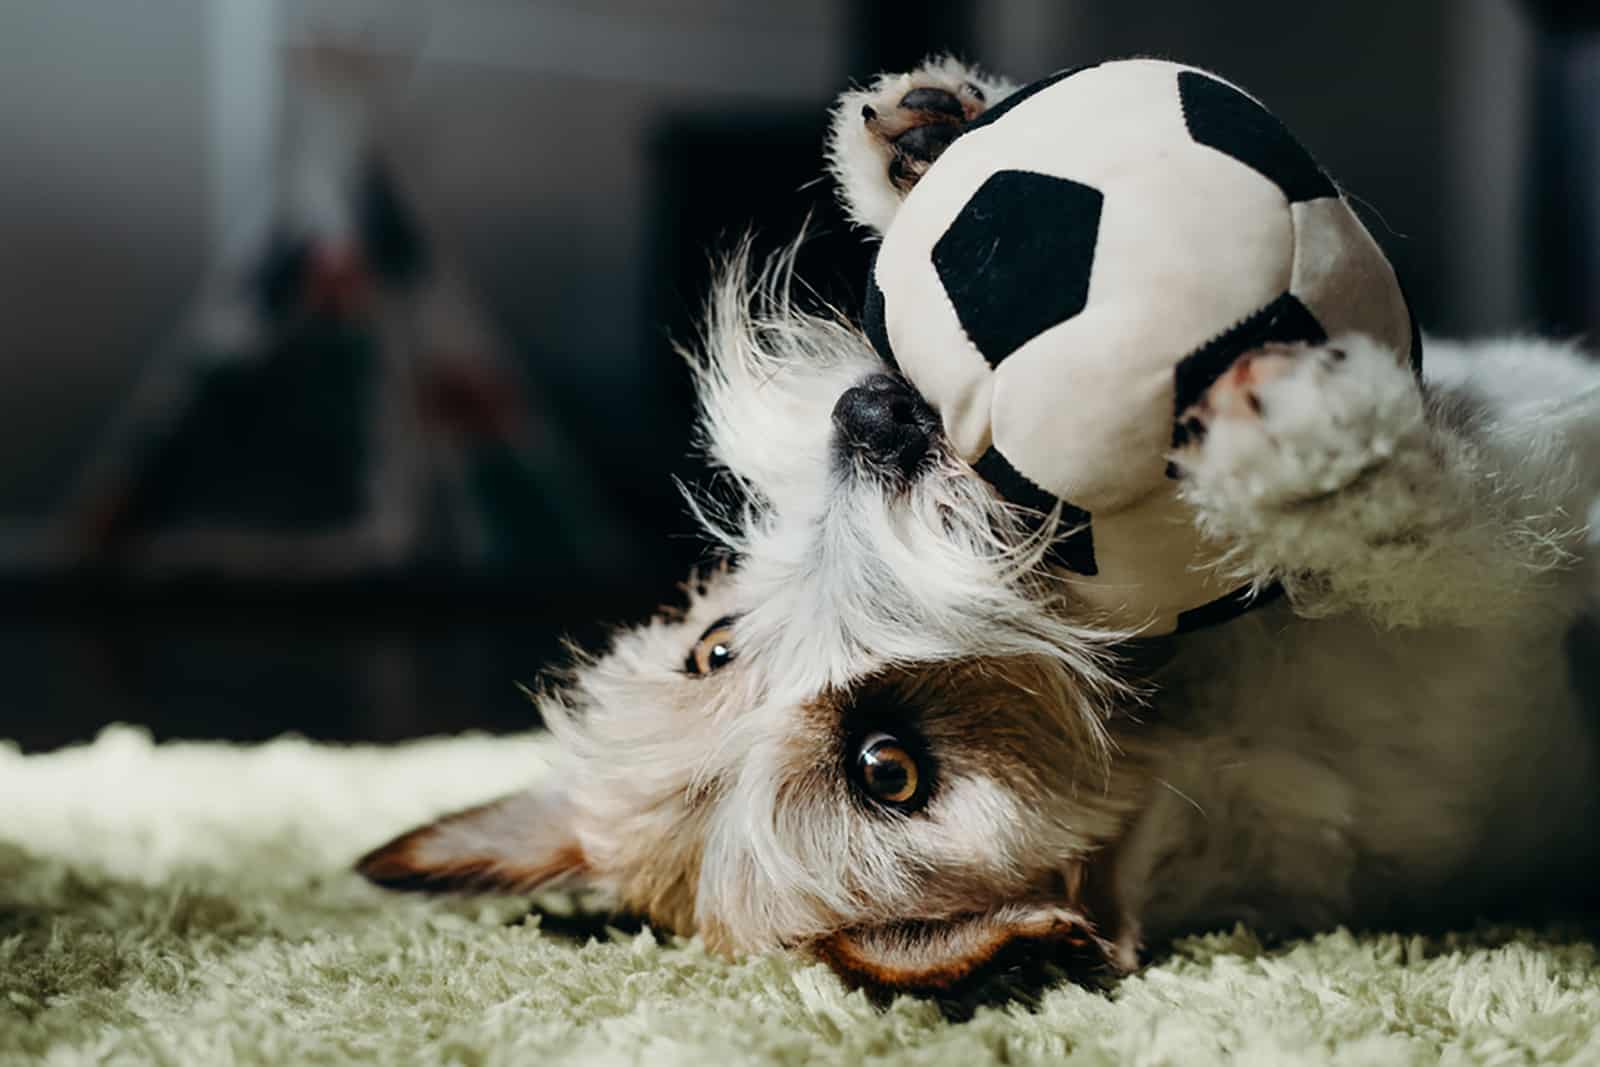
[{"left": 811, "top": 905, "right": 1134, "bottom": 997}]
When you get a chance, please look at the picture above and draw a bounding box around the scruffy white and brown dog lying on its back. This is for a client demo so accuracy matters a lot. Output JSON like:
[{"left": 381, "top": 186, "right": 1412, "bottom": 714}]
[{"left": 358, "top": 59, "right": 1600, "bottom": 997}]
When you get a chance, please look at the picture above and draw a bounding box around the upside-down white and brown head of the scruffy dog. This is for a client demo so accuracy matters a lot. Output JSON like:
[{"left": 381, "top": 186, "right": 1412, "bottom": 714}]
[{"left": 362, "top": 252, "right": 1139, "bottom": 990}]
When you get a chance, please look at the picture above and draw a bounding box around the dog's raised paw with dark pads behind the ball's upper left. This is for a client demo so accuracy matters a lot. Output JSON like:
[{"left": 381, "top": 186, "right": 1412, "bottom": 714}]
[{"left": 827, "top": 58, "right": 1013, "bottom": 234}]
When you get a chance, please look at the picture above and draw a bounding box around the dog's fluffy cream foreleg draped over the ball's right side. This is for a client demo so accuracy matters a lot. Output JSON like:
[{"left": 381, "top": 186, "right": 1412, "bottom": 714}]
[{"left": 1173, "top": 336, "right": 1600, "bottom": 625}]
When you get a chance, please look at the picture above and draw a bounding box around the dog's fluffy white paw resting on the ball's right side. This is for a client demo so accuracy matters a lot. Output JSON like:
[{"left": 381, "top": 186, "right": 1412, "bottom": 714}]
[{"left": 1171, "top": 336, "right": 1426, "bottom": 510}]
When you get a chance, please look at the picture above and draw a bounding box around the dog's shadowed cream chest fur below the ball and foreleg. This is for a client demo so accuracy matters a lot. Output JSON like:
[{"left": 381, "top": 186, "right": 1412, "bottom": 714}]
[{"left": 1118, "top": 608, "right": 1597, "bottom": 934}]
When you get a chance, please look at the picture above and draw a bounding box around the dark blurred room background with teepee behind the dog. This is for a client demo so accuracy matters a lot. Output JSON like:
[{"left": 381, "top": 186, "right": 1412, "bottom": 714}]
[{"left": 0, "top": 0, "right": 1600, "bottom": 749}]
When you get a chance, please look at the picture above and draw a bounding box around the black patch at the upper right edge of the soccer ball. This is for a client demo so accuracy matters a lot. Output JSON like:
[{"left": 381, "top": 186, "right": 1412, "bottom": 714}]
[{"left": 1178, "top": 70, "right": 1339, "bottom": 203}]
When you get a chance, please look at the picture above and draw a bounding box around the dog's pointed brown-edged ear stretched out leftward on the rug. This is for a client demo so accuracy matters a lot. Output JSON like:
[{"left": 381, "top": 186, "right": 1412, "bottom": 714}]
[{"left": 355, "top": 789, "right": 587, "bottom": 893}]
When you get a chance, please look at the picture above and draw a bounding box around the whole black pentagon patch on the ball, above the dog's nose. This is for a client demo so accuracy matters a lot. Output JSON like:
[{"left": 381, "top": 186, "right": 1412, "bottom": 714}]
[{"left": 933, "top": 170, "right": 1106, "bottom": 366}]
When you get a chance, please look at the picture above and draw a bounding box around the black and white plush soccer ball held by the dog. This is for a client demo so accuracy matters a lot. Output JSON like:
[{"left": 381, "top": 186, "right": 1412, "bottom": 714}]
[{"left": 866, "top": 59, "right": 1421, "bottom": 633}]
